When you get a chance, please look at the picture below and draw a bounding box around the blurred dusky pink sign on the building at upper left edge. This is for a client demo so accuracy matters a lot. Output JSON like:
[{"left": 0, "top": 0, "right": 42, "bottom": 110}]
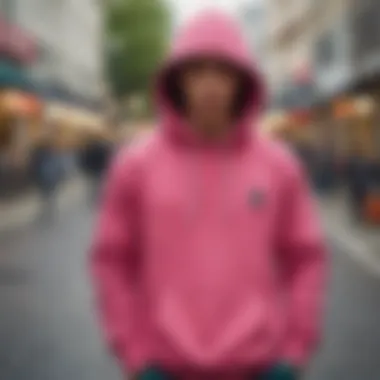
[{"left": 0, "top": 16, "right": 37, "bottom": 62}]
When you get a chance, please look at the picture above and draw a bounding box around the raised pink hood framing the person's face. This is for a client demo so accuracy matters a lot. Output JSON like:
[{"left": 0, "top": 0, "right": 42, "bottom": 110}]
[{"left": 156, "top": 11, "right": 265, "bottom": 147}]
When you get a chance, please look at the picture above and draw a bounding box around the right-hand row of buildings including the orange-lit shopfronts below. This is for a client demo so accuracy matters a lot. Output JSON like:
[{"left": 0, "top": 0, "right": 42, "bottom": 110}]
[{"left": 268, "top": 0, "right": 380, "bottom": 174}]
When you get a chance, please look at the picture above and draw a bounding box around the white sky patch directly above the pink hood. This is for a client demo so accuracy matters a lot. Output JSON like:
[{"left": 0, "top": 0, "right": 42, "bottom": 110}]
[{"left": 169, "top": 0, "right": 251, "bottom": 23}]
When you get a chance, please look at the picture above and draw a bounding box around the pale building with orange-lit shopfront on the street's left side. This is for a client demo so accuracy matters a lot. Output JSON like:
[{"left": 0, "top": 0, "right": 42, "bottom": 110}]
[{"left": 0, "top": 0, "right": 105, "bottom": 197}]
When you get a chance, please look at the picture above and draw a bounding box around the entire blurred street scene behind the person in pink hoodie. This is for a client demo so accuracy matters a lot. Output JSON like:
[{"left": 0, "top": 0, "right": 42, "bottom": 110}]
[{"left": 0, "top": 0, "right": 380, "bottom": 380}]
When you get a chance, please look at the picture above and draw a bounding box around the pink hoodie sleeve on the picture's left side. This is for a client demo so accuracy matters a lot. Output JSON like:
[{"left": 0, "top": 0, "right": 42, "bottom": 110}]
[{"left": 91, "top": 150, "right": 143, "bottom": 368}]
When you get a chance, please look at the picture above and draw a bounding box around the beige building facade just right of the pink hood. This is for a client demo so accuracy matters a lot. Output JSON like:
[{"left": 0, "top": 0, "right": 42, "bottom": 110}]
[{"left": 266, "top": 0, "right": 345, "bottom": 98}]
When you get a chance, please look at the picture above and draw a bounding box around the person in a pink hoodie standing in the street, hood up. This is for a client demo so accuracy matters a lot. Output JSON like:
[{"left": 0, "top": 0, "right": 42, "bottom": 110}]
[{"left": 91, "top": 12, "right": 325, "bottom": 380}]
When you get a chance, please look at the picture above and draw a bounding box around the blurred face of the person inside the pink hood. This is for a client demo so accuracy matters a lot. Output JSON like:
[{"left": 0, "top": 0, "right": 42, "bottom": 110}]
[{"left": 181, "top": 60, "right": 239, "bottom": 128}]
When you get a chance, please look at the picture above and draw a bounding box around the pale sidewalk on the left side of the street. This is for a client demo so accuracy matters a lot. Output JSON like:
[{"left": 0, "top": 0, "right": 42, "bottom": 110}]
[{"left": 0, "top": 177, "right": 85, "bottom": 232}]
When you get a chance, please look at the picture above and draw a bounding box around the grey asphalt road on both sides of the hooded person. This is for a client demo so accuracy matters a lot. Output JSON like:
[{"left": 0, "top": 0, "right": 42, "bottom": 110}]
[{"left": 0, "top": 199, "right": 380, "bottom": 380}]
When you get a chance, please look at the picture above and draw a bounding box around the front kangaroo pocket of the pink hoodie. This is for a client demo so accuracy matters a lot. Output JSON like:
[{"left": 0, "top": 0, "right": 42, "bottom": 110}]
[{"left": 156, "top": 295, "right": 283, "bottom": 366}]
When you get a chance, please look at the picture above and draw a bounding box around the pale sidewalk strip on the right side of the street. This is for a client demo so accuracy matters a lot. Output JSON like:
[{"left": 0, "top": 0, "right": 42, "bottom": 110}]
[{"left": 318, "top": 191, "right": 380, "bottom": 275}]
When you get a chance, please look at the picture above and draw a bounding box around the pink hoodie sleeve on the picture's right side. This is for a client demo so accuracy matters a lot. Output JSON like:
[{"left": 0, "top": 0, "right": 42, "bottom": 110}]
[{"left": 279, "top": 154, "right": 325, "bottom": 367}]
